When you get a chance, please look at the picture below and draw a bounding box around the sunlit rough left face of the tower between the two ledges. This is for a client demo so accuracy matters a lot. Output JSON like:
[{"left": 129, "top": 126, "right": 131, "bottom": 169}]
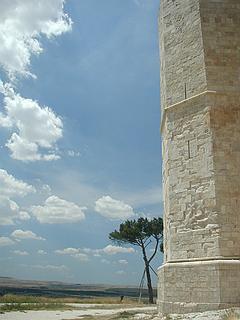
[{"left": 163, "top": 95, "right": 220, "bottom": 261}]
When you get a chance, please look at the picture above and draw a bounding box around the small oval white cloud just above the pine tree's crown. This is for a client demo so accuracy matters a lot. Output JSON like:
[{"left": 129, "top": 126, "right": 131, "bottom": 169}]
[{"left": 95, "top": 196, "right": 135, "bottom": 219}]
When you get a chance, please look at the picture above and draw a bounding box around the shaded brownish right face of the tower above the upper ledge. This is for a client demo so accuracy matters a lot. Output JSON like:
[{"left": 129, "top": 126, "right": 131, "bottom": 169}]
[{"left": 201, "top": 0, "right": 240, "bottom": 94}]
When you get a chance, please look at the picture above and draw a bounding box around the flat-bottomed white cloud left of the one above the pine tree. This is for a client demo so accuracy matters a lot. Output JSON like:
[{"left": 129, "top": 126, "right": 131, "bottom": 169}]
[{"left": 31, "top": 196, "right": 87, "bottom": 224}]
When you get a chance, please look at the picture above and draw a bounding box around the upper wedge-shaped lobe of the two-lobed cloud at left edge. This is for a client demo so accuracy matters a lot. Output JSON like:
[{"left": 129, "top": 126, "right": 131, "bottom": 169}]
[{"left": 0, "top": 169, "right": 36, "bottom": 196}]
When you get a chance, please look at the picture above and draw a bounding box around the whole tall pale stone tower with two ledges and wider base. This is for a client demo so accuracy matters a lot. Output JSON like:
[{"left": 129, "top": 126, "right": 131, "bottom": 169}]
[{"left": 158, "top": 0, "right": 240, "bottom": 313}]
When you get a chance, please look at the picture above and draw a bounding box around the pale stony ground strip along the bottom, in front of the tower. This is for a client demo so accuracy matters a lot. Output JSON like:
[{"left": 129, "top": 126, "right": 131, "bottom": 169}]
[{"left": 0, "top": 305, "right": 240, "bottom": 320}]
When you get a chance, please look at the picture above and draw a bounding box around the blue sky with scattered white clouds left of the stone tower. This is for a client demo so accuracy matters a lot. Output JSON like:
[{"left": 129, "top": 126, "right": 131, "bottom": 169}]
[{"left": 0, "top": 0, "right": 163, "bottom": 285}]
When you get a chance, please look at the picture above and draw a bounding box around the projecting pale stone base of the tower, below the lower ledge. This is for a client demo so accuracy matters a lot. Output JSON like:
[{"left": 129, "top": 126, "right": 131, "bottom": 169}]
[{"left": 158, "top": 260, "right": 240, "bottom": 314}]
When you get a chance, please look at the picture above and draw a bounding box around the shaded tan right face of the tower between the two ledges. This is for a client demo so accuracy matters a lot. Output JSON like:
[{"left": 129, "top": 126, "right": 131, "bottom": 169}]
[{"left": 209, "top": 94, "right": 240, "bottom": 259}]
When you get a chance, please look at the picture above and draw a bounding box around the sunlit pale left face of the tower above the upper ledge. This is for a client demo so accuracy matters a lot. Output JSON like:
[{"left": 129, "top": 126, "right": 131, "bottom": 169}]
[{"left": 159, "top": 0, "right": 206, "bottom": 108}]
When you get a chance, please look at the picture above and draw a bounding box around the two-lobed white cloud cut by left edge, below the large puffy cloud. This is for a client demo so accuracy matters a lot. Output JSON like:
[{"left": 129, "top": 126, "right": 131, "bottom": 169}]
[{"left": 0, "top": 169, "right": 36, "bottom": 225}]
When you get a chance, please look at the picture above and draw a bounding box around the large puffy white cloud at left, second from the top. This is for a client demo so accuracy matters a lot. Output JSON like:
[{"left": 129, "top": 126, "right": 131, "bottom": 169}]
[{"left": 0, "top": 84, "right": 63, "bottom": 162}]
